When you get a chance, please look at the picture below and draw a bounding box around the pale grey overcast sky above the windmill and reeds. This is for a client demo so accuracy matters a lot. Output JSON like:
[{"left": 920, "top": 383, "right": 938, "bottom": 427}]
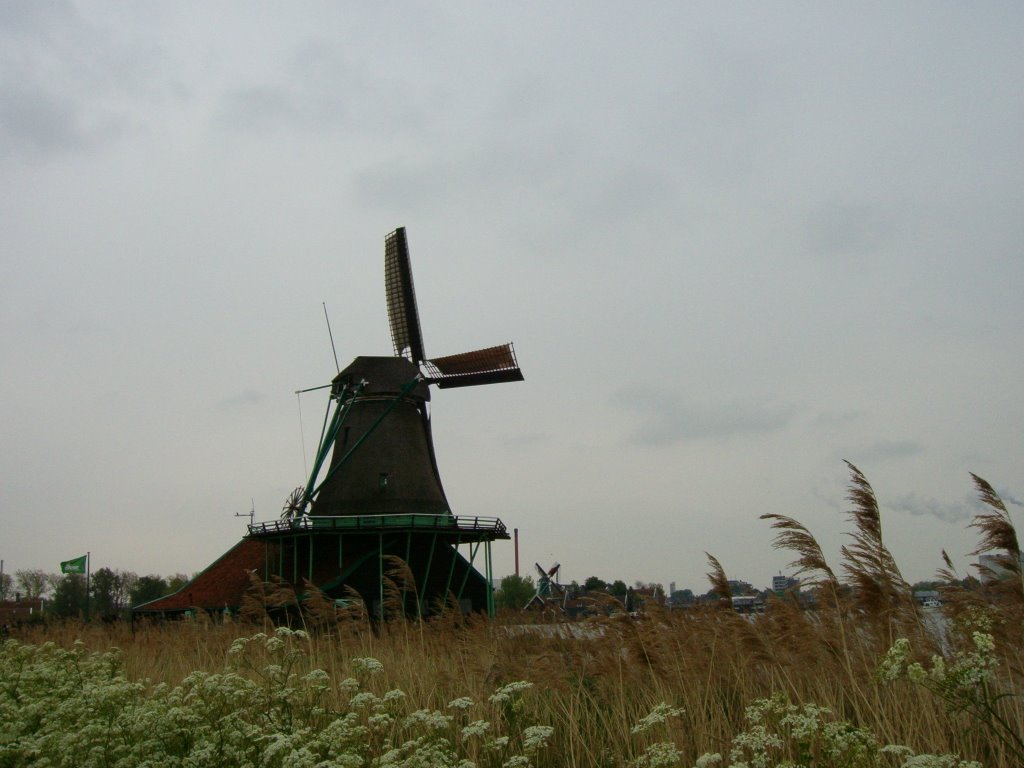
[{"left": 0, "top": 0, "right": 1024, "bottom": 592}]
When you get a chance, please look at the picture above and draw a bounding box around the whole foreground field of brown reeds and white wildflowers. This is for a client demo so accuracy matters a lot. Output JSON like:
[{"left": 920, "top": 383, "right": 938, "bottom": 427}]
[{"left": 0, "top": 466, "right": 1024, "bottom": 768}]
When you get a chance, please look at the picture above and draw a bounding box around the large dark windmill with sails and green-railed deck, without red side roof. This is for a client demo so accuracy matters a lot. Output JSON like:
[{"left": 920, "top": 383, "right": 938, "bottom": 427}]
[{"left": 250, "top": 228, "right": 523, "bottom": 614}]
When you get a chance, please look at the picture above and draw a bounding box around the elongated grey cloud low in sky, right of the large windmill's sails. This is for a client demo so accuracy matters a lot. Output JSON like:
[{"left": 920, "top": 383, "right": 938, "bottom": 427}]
[{"left": 614, "top": 388, "right": 795, "bottom": 445}]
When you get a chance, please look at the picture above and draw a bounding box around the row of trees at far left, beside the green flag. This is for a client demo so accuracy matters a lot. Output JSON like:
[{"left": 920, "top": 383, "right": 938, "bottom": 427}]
[{"left": 0, "top": 568, "right": 188, "bottom": 618}]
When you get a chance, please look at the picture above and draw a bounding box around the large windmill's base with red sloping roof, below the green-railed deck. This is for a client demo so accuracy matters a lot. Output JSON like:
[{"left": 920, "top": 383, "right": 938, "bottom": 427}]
[{"left": 132, "top": 514, "right": 509, "bottom": 620}]
